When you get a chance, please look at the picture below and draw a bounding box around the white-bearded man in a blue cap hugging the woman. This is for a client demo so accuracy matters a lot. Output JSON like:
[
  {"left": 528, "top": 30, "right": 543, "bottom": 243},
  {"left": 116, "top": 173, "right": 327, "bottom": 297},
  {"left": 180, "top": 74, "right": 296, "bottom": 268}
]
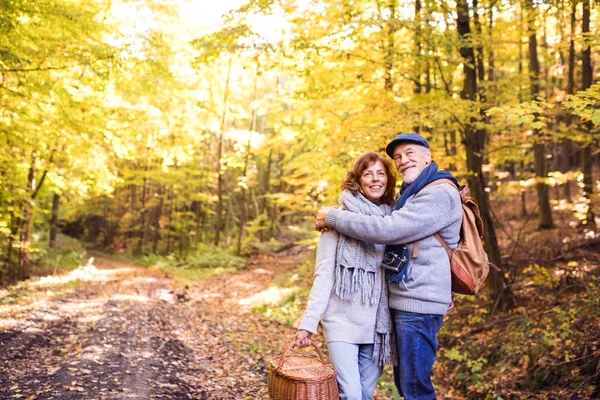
[{"left": 316, "top": 133, "right": 462, "bottom": 400}]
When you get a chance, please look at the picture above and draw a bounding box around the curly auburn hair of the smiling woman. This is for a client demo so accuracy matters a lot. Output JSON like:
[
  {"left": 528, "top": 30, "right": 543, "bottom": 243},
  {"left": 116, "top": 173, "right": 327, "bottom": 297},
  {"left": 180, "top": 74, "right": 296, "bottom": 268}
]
[{"left": 342, "top": 151, "right": 396, "bottom": 205}]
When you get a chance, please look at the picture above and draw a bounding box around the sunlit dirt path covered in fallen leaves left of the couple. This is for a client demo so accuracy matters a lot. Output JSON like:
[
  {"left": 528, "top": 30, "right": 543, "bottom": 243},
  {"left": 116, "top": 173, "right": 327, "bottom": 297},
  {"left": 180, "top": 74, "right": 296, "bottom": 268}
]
[{"left": 0, "top": 249, "right": 308, "bottom": 400}]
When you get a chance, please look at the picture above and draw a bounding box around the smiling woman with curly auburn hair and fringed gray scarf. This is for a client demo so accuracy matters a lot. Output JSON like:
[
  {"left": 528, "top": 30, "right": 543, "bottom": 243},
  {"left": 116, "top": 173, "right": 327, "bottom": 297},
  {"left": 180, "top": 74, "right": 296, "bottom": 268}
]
[{"left": 293, "top": 152, "right": 396, "bottom": 400}]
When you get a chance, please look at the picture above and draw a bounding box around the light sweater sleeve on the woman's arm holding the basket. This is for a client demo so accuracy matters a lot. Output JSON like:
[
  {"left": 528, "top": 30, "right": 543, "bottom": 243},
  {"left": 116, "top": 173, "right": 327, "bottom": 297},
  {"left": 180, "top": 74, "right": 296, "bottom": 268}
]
[{"left": 298, "top": 231, "right": 338, "bottom": 333}]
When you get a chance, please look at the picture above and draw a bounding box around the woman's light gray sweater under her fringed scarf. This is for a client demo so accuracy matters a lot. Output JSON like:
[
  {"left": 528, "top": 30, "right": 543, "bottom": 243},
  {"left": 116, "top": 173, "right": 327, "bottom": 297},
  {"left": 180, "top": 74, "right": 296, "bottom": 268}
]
[{"left": 298, "top": 231, "right": 385, "bottom": 344}]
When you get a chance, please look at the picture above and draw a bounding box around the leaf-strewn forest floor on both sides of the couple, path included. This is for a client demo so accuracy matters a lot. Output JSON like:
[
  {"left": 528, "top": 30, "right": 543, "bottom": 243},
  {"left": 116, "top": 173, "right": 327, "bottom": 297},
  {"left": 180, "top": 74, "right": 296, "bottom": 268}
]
[{"left": 0, "top": 223, "right": 600, "bottom": 400}]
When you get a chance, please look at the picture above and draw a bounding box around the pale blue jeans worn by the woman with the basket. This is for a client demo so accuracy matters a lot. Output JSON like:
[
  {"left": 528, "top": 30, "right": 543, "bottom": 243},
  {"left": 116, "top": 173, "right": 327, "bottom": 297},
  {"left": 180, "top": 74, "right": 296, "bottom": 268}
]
[{"left": 328, "top": 342, "right": 382, "bottom": 400}]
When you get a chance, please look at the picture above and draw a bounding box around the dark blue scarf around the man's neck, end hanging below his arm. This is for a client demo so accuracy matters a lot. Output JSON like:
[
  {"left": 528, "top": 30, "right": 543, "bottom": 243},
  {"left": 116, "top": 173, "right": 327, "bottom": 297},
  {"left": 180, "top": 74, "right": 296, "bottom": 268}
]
[{"left": 385, "top": 161, "right": 459, "bottom": 285}]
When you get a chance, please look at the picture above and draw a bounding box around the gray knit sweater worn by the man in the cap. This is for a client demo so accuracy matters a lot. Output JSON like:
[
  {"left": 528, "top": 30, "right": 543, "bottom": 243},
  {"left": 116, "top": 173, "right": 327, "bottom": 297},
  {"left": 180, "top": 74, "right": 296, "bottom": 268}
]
[{"left": 326, "top": 184, "right": 462, "bottom": 315}]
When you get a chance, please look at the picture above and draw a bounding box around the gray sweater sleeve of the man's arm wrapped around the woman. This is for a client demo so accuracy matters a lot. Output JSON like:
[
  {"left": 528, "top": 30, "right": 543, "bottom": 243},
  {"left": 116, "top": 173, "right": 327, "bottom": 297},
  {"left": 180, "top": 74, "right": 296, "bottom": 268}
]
[{"left": 326, "top": 184, "right": 462, "bottom": 244}]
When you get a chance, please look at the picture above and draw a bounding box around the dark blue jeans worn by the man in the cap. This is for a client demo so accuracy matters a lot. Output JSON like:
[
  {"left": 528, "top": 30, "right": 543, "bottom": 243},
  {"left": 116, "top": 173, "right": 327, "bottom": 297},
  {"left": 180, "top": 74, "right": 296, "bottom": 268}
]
[{"left": 391, "top": 310, "right": 443, "bottom": 400}]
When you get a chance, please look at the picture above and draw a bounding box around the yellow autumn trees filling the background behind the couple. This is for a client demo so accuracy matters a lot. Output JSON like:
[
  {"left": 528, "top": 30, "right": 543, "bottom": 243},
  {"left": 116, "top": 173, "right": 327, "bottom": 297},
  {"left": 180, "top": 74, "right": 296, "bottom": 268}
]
[{"left": 0, "top": 0, "right": 600, "bottom": 307}]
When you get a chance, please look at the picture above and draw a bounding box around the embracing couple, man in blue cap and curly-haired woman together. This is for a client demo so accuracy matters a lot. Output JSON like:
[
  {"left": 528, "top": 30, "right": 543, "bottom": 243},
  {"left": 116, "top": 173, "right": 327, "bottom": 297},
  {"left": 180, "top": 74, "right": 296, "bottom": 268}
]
[{"left": 293, "top": 133, "right": 462, "bottom": 400}]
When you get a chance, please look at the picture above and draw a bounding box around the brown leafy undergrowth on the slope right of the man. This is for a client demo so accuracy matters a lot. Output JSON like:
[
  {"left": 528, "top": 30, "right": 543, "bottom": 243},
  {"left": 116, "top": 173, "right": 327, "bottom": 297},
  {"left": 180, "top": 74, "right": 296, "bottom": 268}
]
[{"left": 434, "top": 255, "right": 600, "bottom": 399}]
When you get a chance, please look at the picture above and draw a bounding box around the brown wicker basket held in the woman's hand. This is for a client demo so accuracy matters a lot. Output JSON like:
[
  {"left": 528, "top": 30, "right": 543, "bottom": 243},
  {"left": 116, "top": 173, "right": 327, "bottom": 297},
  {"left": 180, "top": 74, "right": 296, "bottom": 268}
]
[{"left": 268, "top": 343, "right": 340, "bottom": 400}]
